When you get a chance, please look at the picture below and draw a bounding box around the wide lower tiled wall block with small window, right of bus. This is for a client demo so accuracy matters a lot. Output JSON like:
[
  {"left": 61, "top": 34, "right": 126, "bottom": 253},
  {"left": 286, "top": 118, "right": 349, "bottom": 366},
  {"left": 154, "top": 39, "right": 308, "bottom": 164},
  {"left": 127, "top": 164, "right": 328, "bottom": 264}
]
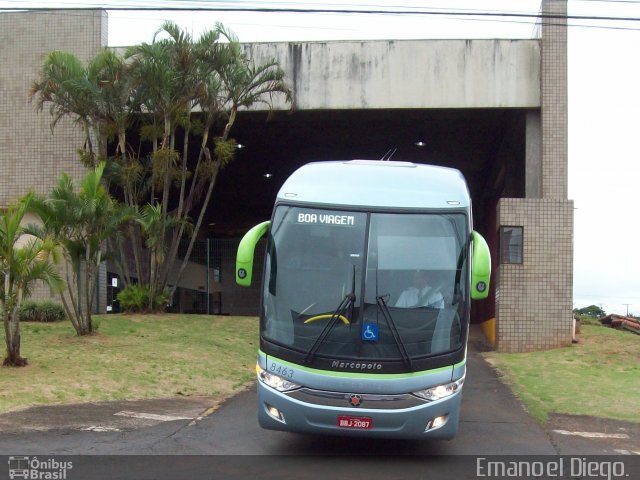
[{"left": 496, "top": 198, "right": 573, "bottom": 352}]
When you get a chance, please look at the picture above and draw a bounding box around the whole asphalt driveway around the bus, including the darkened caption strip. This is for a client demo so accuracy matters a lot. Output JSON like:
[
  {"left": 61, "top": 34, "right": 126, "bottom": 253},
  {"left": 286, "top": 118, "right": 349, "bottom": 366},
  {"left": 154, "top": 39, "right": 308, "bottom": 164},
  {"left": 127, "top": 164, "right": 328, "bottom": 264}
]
[{"left": 0, "top": 330, "right": 640, "bottom": 480}]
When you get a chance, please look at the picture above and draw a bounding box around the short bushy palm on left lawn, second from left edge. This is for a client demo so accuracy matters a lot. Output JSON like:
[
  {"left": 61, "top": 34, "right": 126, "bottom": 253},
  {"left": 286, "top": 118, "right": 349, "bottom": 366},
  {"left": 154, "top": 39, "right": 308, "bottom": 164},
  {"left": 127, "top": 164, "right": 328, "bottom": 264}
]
[{"left": 29, "top": 162, "right": 131, "bottom": 335}]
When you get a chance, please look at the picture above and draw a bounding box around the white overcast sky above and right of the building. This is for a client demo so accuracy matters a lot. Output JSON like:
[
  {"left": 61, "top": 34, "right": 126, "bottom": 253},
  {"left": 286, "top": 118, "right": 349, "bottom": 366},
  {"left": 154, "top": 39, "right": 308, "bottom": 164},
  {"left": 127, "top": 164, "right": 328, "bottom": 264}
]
[{"left": 0, "top": 0, "right": 640, "bottom": 314}]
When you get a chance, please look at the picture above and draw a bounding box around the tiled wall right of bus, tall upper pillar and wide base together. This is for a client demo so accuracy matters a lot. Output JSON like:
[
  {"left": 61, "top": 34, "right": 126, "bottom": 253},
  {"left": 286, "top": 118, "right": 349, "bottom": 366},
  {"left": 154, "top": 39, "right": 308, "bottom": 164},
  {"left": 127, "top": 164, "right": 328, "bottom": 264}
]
[{"left": 496, "top": 0, "right": 573, "bottom": 352}]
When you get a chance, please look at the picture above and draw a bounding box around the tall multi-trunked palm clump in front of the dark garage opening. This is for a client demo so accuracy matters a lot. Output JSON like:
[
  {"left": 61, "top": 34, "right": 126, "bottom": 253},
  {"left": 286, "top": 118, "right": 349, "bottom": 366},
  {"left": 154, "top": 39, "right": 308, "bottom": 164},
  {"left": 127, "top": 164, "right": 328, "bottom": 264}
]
[{"left": 32, "top": 22, "right": 292, "bottom": 304}]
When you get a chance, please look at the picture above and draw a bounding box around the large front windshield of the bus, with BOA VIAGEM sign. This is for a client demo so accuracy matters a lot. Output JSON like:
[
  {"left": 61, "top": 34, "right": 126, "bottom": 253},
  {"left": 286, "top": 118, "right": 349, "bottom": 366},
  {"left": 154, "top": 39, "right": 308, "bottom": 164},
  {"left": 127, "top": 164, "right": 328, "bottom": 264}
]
[{"left": 261, "top": 205, "right": 469, "bottom": 361}]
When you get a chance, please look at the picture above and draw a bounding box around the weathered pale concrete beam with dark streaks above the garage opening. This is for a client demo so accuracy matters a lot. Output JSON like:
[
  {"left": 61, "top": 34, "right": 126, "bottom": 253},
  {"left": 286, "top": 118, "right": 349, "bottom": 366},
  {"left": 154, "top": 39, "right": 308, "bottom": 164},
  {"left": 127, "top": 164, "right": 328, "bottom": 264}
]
[{"left": 245, "top": 40, "right": 541, "bottom": 110}]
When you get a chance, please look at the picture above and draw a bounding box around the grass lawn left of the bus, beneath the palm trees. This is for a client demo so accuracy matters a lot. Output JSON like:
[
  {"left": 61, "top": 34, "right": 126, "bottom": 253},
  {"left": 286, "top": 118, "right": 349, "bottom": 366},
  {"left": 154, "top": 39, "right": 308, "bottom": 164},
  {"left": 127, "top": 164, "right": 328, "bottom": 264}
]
[{"left": 0, "top": 314, "right": 258, "bottom": 413}]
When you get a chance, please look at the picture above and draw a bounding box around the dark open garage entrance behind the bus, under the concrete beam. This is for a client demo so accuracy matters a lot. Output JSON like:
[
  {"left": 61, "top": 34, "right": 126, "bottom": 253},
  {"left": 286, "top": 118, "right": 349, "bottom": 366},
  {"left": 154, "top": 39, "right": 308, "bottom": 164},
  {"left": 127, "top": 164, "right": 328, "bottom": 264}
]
[{"left": 207, "top": 109, "right": 527, "bottom": 322}]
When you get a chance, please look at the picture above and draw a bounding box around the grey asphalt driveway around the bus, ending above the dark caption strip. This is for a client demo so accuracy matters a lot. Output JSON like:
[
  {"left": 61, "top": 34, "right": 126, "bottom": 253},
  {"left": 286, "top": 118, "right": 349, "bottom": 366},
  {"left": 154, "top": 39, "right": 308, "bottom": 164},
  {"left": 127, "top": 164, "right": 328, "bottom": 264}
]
[{"left": 0, "top": 342, "right": 557, "bottom": 455}]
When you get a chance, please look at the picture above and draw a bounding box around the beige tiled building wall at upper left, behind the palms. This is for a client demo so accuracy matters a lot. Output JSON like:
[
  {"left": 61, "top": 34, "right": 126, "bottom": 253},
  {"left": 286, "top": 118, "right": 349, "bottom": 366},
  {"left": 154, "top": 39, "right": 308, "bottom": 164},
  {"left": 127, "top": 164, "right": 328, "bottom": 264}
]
[{"left": 0, "top": 10, "right": 107, "bottom": 311}]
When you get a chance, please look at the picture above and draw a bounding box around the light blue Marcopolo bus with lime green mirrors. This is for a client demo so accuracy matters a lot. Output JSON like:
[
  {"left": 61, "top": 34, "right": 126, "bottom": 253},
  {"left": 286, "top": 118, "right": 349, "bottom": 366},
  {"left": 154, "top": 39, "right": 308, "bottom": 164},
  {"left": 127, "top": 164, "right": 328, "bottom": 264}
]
[{"left": 236, "top": 160, "right": 491, "bottom": 438}]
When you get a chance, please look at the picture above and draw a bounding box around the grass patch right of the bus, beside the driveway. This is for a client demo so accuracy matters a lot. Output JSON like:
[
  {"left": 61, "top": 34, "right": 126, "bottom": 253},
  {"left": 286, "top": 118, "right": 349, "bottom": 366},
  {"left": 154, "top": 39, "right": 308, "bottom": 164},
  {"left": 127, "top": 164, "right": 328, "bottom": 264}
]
[{"left": 485, "top": 324, "right": 640, "bottom": 422}]
